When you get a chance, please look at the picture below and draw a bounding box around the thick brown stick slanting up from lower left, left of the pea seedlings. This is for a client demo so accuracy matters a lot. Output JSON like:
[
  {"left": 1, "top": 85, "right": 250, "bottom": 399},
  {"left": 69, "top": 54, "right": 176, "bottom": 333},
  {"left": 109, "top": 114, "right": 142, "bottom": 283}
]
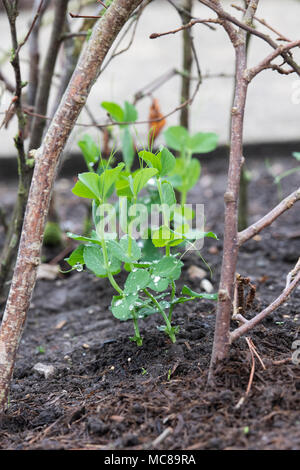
[{"left": 0, "top": 0, "right": 142, "bottom": 412}]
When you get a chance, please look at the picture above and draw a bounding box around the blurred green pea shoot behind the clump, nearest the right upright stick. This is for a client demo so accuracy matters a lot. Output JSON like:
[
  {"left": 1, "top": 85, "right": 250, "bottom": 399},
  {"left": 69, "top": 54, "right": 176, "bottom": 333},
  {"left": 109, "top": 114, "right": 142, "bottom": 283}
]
[{"left": 164, "top": 126, "right": 218, "bottom": 204}]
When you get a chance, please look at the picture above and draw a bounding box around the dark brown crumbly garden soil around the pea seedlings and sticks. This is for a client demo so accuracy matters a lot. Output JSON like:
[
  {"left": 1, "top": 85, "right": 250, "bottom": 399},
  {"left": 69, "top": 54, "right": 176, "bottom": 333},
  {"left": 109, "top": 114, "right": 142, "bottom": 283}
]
[{"left": 0, "top": 155, "right": 300, "bottom": 450}]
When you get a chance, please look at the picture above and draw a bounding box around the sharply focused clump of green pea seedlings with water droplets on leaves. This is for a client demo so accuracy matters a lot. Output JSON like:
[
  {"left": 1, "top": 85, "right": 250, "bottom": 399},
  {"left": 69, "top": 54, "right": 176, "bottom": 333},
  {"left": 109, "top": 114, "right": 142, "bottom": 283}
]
[{"left": 66, "top": 147, "right": 217, "bottom": 346}]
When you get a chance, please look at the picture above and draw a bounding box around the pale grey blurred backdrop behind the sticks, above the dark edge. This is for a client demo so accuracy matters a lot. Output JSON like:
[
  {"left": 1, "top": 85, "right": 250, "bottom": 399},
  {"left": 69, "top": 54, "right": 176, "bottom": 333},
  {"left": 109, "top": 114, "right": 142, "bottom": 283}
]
[{"left": 0, "top": 0, "right": 300, "bottom": 163}]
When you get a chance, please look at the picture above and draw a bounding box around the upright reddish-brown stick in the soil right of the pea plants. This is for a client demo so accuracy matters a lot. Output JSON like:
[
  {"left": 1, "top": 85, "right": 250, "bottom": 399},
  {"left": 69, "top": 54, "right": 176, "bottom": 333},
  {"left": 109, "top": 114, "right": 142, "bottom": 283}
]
[{"left": 209, "top": 0, "right": 259, "bottom": 370}]
